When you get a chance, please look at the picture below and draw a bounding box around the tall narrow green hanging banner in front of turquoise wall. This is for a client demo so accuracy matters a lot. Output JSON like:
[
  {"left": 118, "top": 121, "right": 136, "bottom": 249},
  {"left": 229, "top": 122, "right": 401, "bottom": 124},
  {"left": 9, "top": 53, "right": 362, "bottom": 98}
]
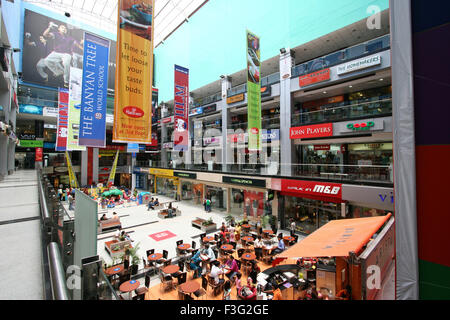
[{"left": 247, "top": 30, "right": 261, "bottom": 151}]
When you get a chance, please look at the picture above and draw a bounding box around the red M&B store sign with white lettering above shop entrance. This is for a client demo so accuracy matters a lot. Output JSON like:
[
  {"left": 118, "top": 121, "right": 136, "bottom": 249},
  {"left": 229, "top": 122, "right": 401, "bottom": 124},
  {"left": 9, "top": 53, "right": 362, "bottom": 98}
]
[{"left": 272, "top": 179, "right": 342, "bottom": 202}]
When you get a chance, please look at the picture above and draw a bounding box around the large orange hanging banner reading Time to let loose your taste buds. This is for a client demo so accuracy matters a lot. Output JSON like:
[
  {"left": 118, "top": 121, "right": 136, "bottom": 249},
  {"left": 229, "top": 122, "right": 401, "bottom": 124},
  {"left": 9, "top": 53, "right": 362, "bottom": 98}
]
[{"left": 113, "top": 0, "right": 154, "bottom": 144}]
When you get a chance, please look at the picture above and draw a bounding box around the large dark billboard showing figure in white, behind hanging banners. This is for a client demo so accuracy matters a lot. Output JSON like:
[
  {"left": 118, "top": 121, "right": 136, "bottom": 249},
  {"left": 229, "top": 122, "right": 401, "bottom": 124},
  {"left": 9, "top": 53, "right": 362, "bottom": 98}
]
[{"left": 22, "top": 9, "right": 116, "bottom": 89}]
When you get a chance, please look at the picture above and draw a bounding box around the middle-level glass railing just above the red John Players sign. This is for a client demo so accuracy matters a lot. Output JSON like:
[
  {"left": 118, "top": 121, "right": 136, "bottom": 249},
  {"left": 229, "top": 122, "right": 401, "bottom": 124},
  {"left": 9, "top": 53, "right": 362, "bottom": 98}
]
[{"left": 292, "top": 99, "right": 392, "bottom": 126}]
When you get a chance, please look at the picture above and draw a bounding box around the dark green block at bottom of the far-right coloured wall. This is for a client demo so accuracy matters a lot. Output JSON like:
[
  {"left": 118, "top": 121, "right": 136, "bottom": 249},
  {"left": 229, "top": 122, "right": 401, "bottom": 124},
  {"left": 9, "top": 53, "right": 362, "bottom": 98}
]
[{"left": 419, "top": 260, "right": 450, "bottom": 300}]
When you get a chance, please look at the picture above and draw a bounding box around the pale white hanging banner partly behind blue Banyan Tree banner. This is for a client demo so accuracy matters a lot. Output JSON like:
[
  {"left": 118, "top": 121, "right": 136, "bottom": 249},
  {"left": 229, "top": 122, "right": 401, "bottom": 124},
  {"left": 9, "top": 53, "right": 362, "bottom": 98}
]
[{"left": 67, "top": 67, "right": 86, "bottom": 151}]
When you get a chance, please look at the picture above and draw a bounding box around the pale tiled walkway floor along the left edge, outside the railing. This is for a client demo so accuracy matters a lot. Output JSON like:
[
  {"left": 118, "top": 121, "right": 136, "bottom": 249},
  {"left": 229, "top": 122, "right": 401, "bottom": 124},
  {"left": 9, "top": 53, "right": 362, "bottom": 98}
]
[{"left": 0, "top": 170, "right": 44, "bottom": 300}]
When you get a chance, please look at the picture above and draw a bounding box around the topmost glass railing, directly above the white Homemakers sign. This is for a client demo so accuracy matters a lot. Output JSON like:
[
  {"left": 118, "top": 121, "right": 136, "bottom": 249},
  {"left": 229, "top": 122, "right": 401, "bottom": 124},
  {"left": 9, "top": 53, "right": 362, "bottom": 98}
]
[{"left": 292, "top": 34, "right": 391, "bottom": 78}]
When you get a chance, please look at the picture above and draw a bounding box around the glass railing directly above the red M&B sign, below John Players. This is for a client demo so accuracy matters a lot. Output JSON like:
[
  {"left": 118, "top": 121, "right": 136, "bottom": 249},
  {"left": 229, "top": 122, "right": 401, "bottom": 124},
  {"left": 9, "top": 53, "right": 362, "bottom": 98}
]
[{"left": 292, "top": 164, "right": 393, "bottom": 183}]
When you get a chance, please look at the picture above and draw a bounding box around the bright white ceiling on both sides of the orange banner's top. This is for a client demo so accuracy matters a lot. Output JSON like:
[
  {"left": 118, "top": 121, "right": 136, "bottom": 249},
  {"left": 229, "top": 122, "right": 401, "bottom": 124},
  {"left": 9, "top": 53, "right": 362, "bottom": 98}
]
[{"left": 24, "top": 0, "right": 208, "bottom": 47}]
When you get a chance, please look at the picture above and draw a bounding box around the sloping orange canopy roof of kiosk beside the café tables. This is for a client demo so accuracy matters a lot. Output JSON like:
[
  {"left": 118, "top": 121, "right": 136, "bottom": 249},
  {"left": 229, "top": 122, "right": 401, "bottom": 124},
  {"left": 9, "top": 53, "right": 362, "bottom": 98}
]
[{"left": 276, "top": 213, "right": 391, "bottom": 259}]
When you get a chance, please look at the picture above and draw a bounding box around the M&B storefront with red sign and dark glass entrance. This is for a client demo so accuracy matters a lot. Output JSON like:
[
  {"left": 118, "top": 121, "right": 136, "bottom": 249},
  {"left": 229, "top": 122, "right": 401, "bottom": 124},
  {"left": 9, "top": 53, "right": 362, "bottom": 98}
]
[{"left": 271, "top": 179, "right": 346, "bottom": 234}]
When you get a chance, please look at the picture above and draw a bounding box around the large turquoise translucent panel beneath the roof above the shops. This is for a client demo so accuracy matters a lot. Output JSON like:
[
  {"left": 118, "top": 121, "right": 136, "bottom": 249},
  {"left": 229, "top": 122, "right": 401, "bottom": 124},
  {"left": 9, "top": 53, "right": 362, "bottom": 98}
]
[{"left": 155, "top": 0, "right": 389, "bottom": 101}]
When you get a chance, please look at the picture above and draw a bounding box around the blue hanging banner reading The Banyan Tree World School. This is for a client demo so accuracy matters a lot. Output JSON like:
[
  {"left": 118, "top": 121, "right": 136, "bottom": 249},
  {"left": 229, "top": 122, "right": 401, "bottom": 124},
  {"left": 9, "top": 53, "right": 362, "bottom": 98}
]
[{"left": 78, "top": 32, "right": 109, "bottom": 148}]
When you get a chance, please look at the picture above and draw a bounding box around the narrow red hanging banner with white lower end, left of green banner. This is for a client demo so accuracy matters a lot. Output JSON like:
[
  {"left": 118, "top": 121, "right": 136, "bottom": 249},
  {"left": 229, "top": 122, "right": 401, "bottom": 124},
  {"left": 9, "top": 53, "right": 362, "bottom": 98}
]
[{"left": 173, "top": 65, "right": 189, "bottom": 151}]
